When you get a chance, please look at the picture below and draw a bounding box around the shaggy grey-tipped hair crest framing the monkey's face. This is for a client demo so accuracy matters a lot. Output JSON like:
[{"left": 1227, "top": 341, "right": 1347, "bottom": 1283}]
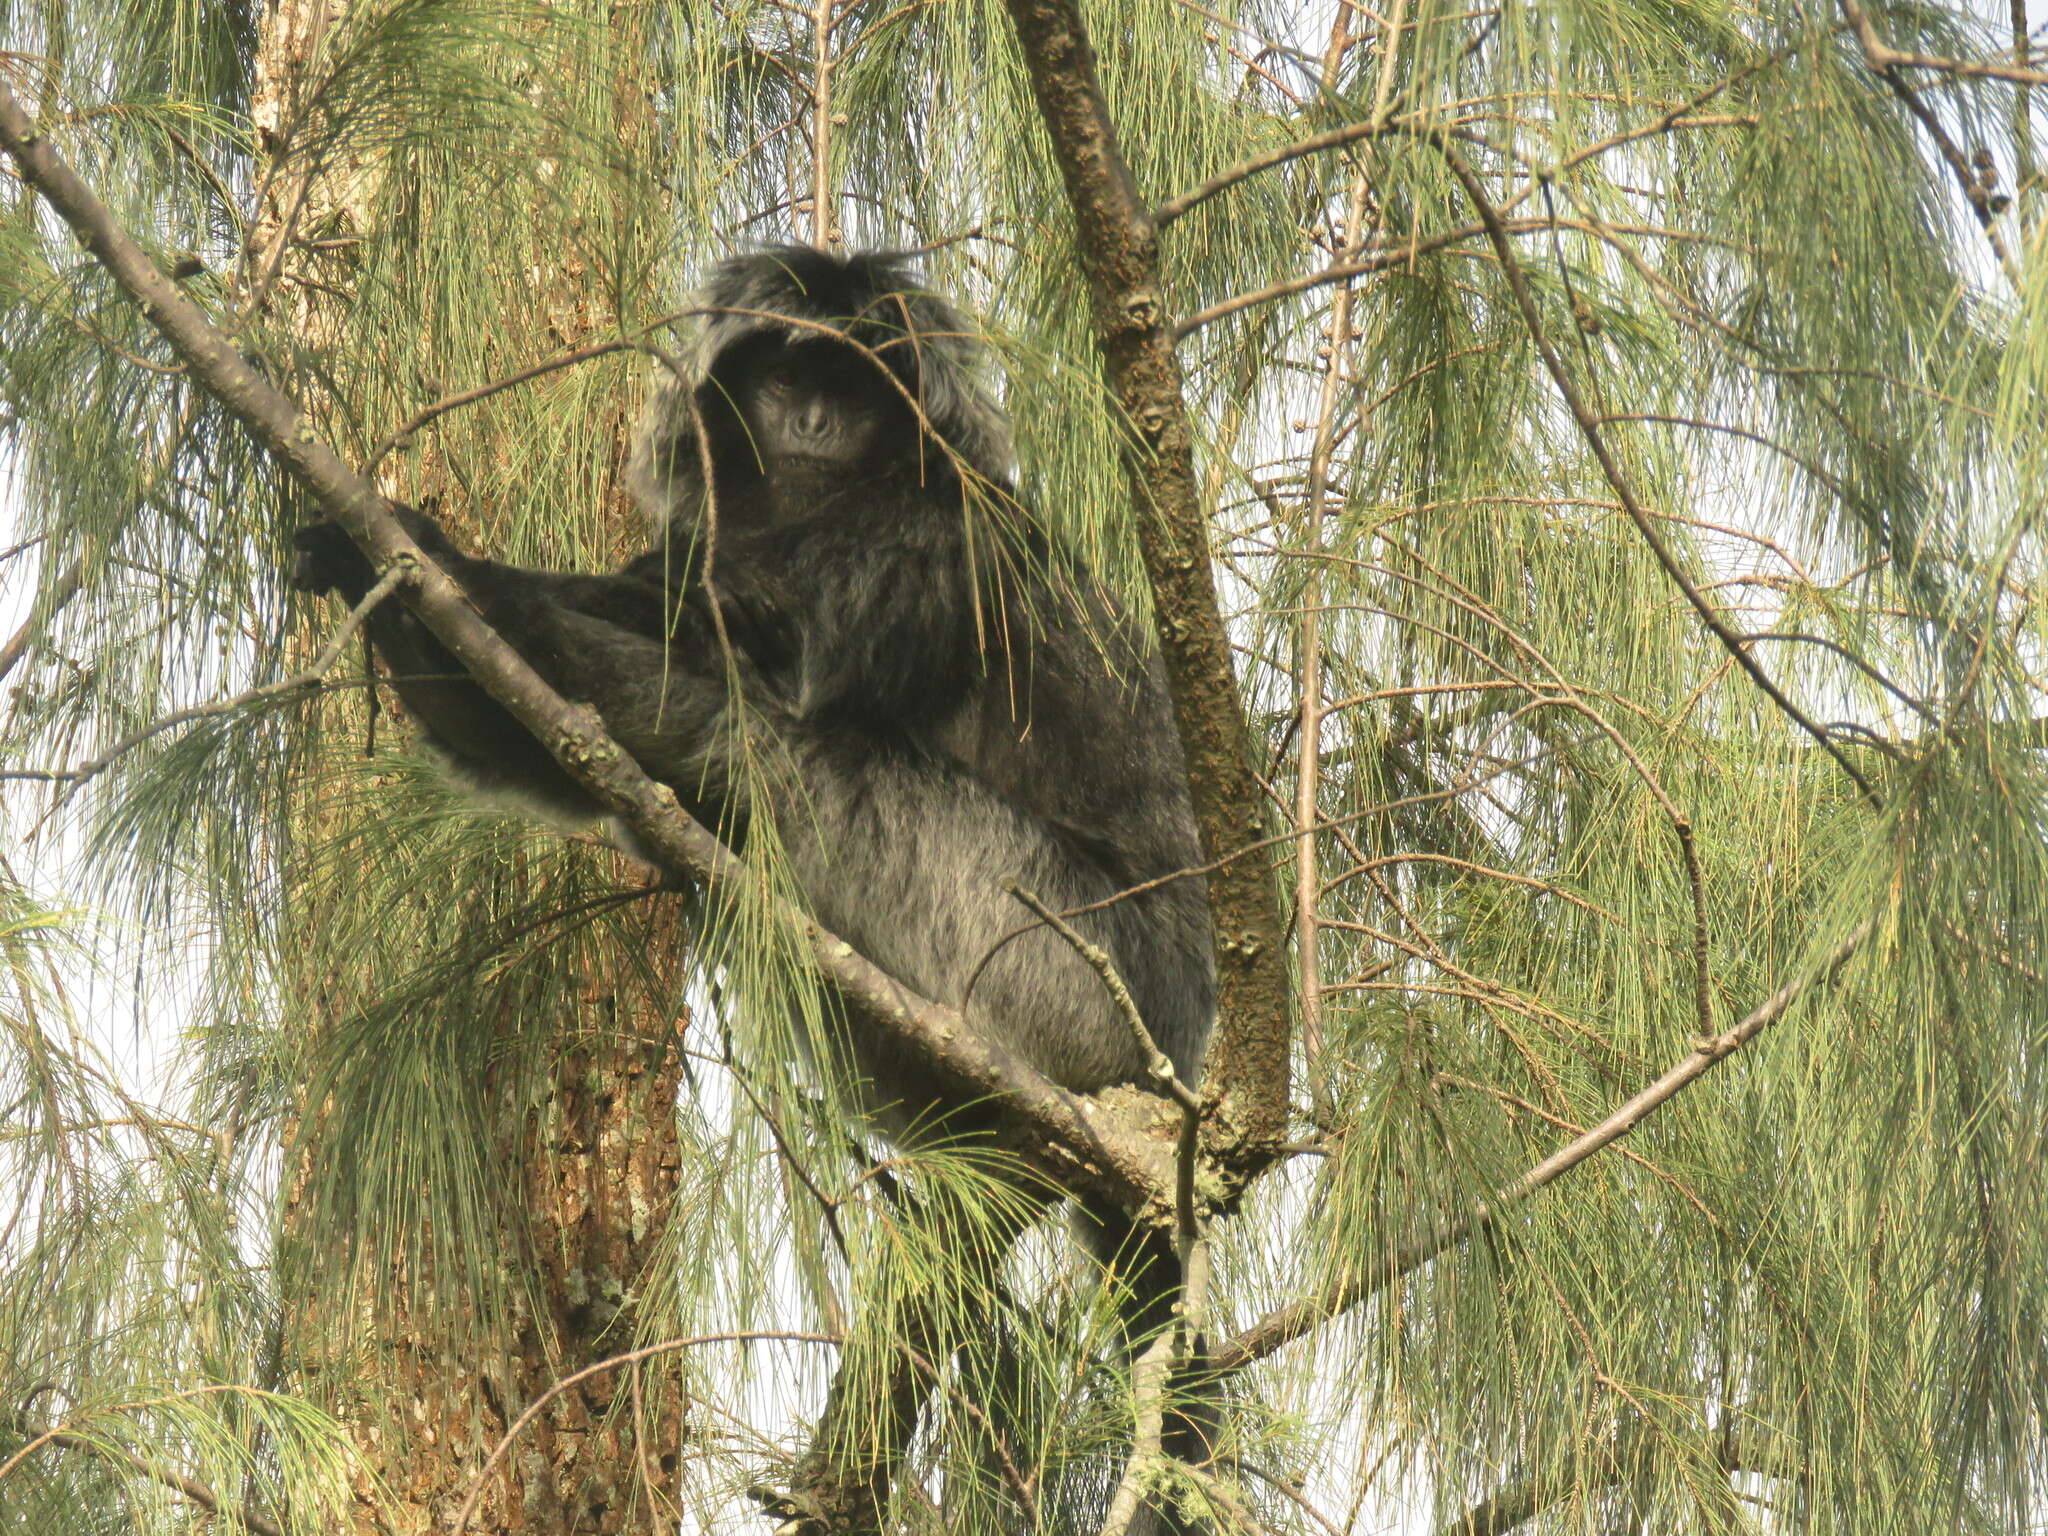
[{"left": 627, "top": 246, "right": 1010, "bottom": 528}]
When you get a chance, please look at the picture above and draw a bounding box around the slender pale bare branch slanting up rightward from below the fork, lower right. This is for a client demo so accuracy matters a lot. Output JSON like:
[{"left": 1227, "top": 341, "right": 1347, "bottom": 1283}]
[{"left": 1214, "top": 924, "right": 1870, "bottom": 1370}]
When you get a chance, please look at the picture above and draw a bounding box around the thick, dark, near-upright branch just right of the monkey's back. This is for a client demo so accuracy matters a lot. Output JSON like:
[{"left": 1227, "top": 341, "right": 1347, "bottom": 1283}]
[{"left": 1008, "top": 0, "right": 1288, "bottom": 1171}]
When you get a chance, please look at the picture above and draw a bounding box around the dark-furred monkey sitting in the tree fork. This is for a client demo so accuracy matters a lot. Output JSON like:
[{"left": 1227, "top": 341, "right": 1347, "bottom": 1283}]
[{"left": 295, "top": 248, "right": 1214, "bottom": 1523}]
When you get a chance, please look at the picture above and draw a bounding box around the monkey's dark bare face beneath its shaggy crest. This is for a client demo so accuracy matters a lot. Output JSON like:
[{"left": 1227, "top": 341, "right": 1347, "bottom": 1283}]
[{"left": 713, "top": 336, "right": 915, "bottom": 479}]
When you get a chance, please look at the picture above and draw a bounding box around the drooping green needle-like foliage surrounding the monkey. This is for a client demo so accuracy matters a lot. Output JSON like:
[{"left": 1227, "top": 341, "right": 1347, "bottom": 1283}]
[{"left": 0, "top": 0, "right": 2048, "bottom": 1536}]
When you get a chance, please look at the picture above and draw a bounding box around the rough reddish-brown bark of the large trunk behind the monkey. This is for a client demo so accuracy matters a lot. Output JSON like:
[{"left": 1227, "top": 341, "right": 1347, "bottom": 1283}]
[{"left": 242, "top": 0, "right": 684, "bottom": 1536}]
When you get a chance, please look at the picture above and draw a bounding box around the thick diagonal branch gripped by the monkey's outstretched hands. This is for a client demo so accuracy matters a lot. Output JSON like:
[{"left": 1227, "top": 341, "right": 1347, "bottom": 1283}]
[{"left": 0, "top": 82, "right": 1171, "bottom": 1208}]
